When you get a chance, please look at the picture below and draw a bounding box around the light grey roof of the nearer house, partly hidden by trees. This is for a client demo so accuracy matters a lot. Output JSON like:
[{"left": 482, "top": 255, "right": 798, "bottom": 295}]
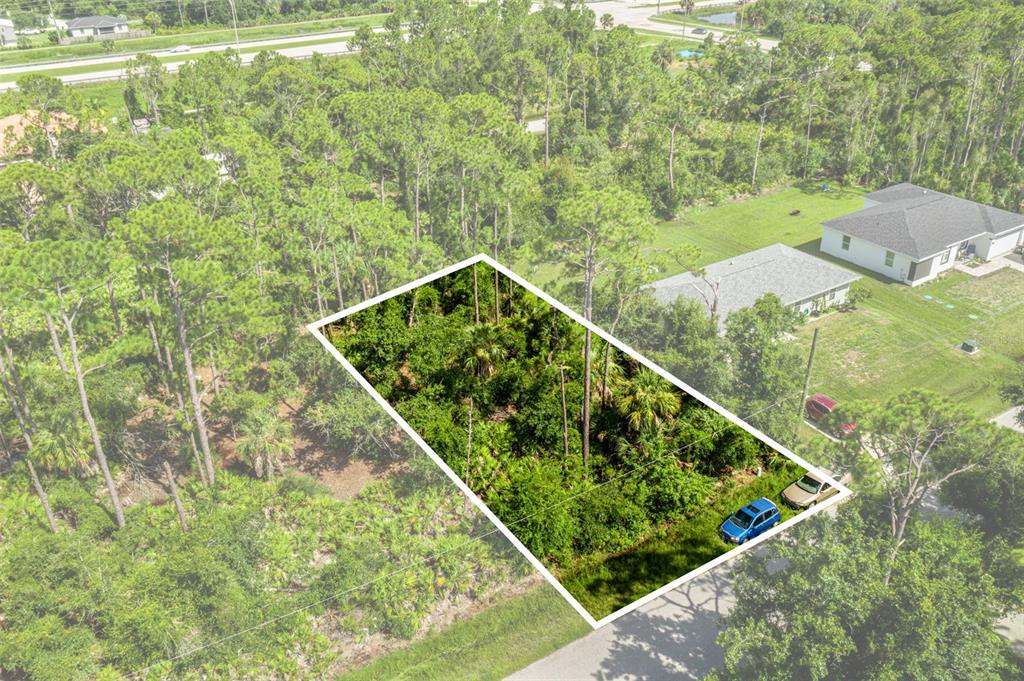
[{"left": 651, "top": 244, "right": 860, "bottom": 322}]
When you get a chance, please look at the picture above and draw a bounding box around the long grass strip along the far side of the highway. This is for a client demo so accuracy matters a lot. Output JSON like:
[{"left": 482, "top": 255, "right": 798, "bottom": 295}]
[{"left": 0, "top": 14, "right": 387, "bottom": 67}]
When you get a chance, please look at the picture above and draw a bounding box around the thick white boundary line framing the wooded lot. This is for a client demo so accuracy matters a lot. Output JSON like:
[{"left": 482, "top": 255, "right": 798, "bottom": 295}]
[{"left": 306, "top": 253, "right": 852, "bottom": 629}]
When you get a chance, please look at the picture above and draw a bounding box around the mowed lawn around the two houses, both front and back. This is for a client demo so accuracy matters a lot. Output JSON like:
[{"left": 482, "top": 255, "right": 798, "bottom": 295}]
[{"left": 652, "top": 186, "right": 1024, "bottom": 419}]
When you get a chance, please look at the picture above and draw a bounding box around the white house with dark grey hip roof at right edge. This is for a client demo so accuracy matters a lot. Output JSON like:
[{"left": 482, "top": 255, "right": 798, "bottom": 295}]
[{"left": 821, "top": 182, "right": 1024, "bottom": 286}]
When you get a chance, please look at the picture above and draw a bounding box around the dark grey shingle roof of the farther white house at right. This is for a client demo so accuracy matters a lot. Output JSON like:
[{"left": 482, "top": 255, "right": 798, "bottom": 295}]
[{"left": 824, "top": 182, "right": 1024, "bottom": 259}]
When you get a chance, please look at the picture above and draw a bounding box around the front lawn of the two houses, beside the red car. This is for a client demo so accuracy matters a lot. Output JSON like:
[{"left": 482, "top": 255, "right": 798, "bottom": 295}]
[{"left": 799, "top": 269, "right": 1024, "bottom": 419}]
